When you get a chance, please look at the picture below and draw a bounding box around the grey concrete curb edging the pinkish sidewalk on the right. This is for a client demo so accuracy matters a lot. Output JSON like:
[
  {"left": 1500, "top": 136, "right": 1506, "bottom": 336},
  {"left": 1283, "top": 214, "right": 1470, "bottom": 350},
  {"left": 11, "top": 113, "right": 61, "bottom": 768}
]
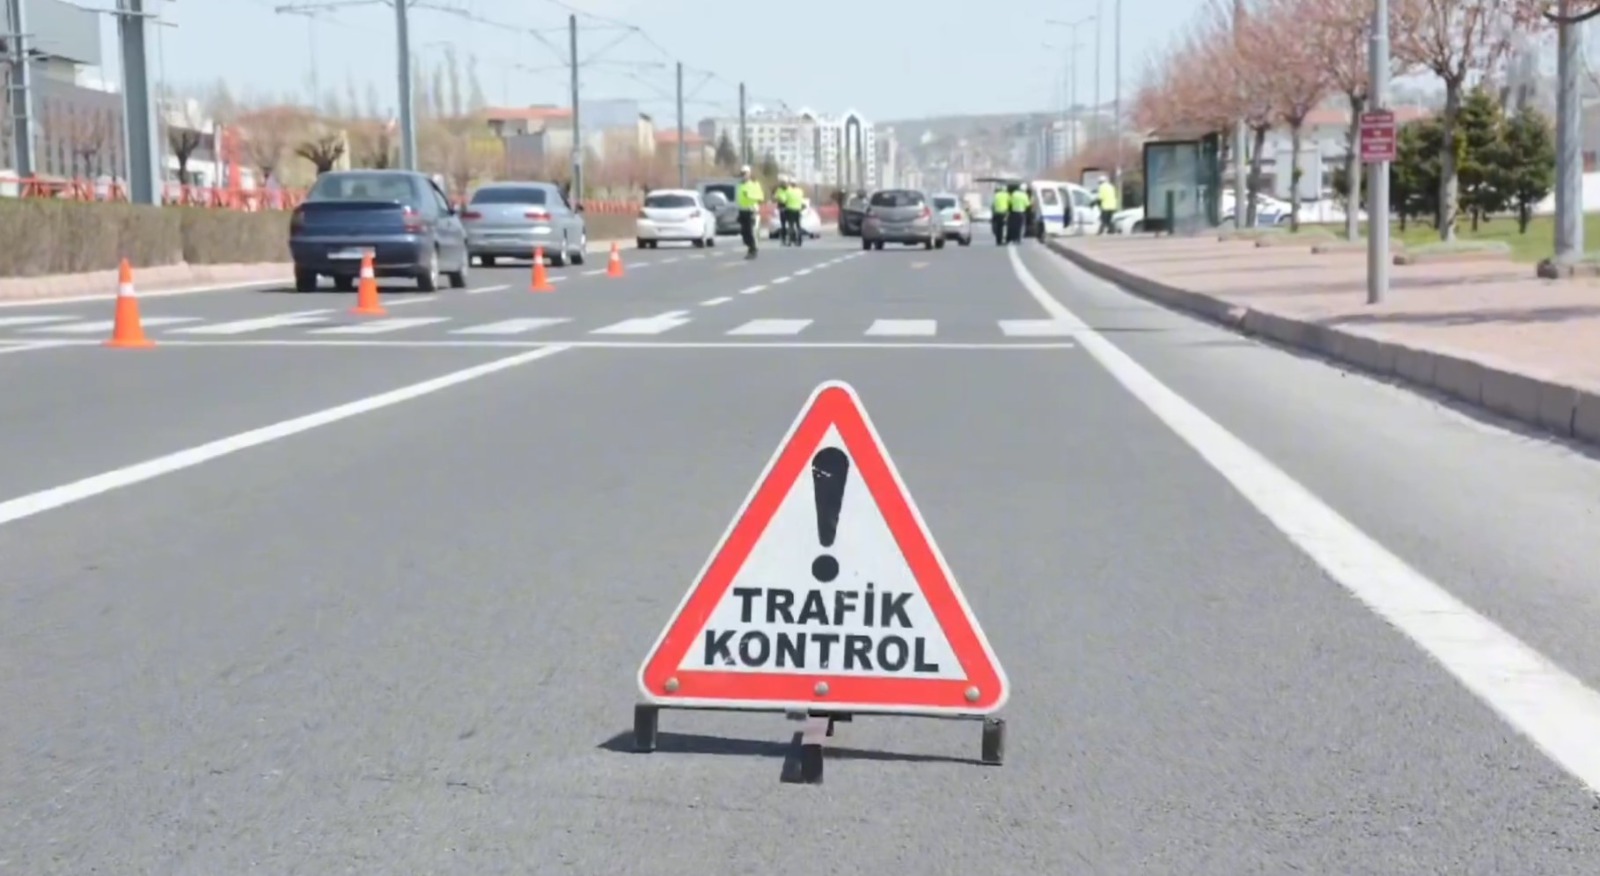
[{"left": 1046, "top": 241, "right": 1600, "bottom": 446}]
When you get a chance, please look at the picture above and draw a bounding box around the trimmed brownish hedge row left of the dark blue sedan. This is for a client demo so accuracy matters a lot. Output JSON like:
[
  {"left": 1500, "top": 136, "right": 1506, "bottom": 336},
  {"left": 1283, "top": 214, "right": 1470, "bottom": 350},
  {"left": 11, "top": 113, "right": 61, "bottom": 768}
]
[{"left": 0, "top": 198, "right": 634, "bottom": 277}]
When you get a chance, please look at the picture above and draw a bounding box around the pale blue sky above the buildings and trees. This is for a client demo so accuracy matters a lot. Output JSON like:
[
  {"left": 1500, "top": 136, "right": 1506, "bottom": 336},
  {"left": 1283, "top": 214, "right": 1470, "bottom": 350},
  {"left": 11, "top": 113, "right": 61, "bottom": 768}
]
[{"left": 84, "top": 0, "right": 1202, "bottom": 126}]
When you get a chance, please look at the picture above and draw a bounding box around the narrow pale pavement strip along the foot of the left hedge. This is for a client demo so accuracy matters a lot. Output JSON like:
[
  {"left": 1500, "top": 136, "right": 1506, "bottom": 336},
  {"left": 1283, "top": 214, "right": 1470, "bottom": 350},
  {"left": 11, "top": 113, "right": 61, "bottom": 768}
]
[{"left": 0, "top": 240, "right": 652, "bottom": 302}]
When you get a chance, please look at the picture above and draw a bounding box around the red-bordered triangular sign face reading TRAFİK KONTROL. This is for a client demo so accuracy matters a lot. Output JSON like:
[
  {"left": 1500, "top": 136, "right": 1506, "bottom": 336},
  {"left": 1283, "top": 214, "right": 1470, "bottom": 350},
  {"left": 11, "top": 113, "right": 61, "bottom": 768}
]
[{"left": 638, "top": 382, "right": 1010, "bottom": 715}]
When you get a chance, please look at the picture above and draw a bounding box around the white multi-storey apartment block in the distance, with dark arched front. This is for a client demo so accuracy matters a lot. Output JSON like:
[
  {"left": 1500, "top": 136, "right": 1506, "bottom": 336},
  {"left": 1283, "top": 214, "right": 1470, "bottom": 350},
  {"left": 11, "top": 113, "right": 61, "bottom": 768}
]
[{"left": 699, "top": 107, "right": 882, "bottom": 189}]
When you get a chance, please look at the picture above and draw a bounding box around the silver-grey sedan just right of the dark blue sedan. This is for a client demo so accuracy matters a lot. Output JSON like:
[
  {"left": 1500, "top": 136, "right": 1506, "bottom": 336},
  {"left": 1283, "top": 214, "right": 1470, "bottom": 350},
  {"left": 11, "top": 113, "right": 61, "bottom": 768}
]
[{"left": 461, "top": 182, "right": 589, "bottom": 267}]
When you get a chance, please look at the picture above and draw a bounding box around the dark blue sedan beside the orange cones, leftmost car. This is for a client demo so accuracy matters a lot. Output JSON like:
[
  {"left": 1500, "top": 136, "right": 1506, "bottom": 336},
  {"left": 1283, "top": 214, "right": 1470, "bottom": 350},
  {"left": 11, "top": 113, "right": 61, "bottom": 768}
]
[{"left": 290, "top": 169, "right": 470, "bottom": 293}]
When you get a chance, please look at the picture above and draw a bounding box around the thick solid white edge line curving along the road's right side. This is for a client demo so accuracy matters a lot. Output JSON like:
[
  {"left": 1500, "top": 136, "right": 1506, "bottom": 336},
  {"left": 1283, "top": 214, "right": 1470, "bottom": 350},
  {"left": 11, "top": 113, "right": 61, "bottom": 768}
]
[{"left": 1006, "top": 248, "right": 1600, "bottom": 793}]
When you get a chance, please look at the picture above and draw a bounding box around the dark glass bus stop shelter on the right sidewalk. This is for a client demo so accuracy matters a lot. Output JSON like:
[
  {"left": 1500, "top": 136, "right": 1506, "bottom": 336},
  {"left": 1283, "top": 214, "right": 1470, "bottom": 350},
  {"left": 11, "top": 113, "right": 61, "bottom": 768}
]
[{"left": 1144, "top": 129, "right": 1222, "bottom": 233}]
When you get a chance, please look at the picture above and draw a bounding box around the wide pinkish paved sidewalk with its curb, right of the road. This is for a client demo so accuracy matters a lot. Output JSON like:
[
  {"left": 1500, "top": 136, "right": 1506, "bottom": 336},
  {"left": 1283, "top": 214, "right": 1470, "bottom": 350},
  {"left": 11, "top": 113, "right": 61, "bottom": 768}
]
[{"left": 1048, "top": 237, "right": 1600, "bottom": 444}]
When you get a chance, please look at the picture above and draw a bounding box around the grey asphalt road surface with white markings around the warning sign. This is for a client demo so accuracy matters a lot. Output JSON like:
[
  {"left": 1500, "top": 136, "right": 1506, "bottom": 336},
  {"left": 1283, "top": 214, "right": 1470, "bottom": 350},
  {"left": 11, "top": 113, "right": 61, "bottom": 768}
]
[{"left": 0, "top": 230, "right": 1600, "bottom": 876}]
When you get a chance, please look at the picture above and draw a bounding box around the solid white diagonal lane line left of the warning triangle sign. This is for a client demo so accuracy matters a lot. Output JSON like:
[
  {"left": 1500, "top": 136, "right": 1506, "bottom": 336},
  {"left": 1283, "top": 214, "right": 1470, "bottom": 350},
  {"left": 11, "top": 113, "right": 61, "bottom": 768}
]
[{"left": 0, "top": 340, "right": 566, "bottom": 526}]
